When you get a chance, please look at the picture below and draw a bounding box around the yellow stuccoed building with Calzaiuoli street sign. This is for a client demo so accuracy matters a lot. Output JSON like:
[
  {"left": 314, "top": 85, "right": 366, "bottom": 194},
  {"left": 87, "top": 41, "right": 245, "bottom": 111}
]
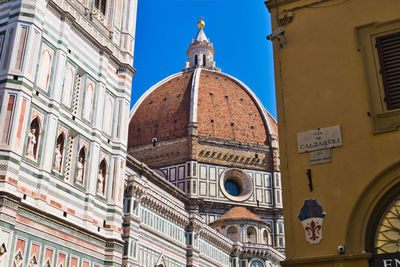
[{"left": 265, "top": 0, "right": 400, "bottom": 267}]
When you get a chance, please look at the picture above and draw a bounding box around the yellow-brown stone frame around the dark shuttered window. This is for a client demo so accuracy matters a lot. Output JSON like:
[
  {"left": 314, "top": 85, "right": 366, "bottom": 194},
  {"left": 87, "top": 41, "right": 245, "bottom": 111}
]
[{"left": 356, "top": 20, "right": 400, "bottom": 134}]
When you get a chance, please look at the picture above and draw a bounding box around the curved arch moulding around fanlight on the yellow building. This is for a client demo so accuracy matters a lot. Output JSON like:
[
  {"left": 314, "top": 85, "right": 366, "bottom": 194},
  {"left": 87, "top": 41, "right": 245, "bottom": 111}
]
[{"left": 346, "top": 161, "right": 400, "bottom": 253}]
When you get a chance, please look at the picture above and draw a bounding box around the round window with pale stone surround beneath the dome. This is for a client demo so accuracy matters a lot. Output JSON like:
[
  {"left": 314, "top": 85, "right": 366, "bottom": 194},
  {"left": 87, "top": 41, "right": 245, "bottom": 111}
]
[{"left": 219, "top": 169, "right": 253, "bottom": 201}]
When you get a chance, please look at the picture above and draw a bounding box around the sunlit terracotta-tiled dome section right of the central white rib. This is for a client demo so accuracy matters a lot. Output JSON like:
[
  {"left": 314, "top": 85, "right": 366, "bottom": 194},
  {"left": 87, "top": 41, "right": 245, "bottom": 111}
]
[{"left": 197, "top": 71, "right": 267, "bottom": 144}]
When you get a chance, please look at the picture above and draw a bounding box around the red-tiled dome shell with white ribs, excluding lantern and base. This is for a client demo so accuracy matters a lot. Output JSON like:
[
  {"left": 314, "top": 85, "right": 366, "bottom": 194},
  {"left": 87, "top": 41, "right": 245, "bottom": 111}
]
[{"left": 128, "top": 68, "right": 277, "bottom": 148}]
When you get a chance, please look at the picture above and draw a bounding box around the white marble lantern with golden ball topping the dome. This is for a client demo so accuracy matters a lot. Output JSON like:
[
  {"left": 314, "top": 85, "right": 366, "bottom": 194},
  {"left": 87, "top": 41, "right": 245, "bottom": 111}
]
[{"left": 184, "top": 17, "right": 221, "bottom": 71}]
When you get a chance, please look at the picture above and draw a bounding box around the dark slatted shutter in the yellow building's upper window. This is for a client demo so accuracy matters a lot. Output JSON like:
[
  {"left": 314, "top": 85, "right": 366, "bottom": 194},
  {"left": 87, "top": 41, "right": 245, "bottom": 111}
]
[{"left": 376, "top": 32, "right": 400, "bottom": 109}]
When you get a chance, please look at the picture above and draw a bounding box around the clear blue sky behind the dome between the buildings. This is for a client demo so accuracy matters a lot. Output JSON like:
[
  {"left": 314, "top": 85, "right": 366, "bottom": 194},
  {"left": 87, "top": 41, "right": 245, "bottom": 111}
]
[{"left": 131, "top": 0, "right": 276, "bottom": 118}]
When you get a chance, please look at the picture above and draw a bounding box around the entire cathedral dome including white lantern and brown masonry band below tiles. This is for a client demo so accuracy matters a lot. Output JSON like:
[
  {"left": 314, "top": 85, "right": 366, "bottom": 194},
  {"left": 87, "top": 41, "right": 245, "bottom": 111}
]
[{"left": 128, "top": 18, "right": 277, "bottom": 171}]
